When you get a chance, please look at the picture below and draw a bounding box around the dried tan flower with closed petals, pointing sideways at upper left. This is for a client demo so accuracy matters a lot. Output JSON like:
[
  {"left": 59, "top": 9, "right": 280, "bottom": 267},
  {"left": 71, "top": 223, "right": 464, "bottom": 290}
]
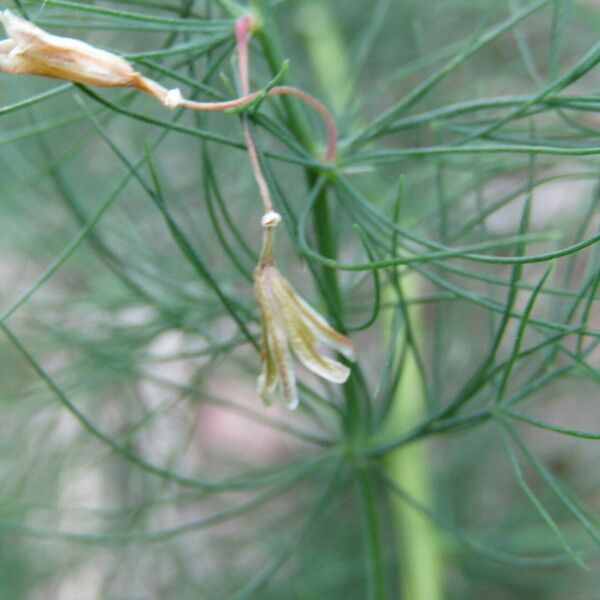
[{"left": 0, "top": 10, "right": 182, "bottom": 108}]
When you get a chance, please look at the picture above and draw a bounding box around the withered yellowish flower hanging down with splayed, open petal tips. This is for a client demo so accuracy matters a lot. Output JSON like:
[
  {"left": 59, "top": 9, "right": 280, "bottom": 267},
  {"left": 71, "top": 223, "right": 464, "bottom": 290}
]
[{"left": 254, "top": 212, "right": 354, "bottom": 409}]
